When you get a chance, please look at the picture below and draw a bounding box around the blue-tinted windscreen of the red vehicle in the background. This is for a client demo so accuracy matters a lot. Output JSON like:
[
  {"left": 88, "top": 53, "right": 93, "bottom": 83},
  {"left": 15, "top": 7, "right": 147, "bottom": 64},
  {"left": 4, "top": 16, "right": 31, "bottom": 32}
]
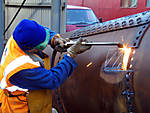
[{"left": 67, "top": 9, "right": 99, "bottom": 25}]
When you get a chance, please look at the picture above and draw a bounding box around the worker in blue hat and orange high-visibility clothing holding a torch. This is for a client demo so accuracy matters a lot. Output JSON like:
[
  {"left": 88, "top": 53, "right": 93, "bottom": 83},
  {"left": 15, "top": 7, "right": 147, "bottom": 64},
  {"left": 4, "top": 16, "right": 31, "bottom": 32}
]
[{"left": 0, "top": 19, "right": 90, "bottom": 113}]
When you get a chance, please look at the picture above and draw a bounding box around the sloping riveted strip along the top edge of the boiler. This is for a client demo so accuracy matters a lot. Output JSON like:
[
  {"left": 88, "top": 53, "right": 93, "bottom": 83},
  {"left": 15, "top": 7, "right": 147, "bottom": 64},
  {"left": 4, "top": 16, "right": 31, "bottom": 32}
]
[{"left": 71, "top": 11, "right": 150, "bottom": 38}]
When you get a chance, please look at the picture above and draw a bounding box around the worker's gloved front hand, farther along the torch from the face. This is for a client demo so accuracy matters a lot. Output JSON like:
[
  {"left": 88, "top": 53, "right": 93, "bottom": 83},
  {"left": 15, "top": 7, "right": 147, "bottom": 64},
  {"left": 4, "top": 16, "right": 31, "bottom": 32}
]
[{"left": 67, "top": 38, "right": 91, "bottom": 58}]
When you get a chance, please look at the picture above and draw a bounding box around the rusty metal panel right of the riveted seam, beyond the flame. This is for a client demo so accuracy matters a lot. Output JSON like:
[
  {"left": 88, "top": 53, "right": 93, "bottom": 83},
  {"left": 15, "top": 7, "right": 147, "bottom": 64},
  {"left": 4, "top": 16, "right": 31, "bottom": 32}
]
[{"left": 132, "top": 29, "right": 150, "bottom": 113}]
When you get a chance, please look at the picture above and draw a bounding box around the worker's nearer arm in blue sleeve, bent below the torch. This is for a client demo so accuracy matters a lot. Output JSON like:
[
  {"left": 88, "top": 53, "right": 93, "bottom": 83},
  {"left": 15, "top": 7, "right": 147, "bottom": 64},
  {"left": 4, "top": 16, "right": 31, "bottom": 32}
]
[{"left": 9, "top": 55, "right": 77, "bottom": 90}]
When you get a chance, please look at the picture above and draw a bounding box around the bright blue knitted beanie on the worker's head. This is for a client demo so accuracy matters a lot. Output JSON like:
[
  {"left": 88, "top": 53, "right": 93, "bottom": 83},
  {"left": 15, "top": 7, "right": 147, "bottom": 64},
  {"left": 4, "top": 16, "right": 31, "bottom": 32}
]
[{"left": 13, "top": 19, "right": 46, "bottom": 50}]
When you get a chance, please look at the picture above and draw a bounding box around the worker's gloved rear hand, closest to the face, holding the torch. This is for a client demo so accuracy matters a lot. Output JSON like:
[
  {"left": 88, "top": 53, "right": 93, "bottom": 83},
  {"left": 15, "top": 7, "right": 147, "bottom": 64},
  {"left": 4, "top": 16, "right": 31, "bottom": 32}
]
[{"left": 51, "top": 34, "right": 68, "bottom": 48}]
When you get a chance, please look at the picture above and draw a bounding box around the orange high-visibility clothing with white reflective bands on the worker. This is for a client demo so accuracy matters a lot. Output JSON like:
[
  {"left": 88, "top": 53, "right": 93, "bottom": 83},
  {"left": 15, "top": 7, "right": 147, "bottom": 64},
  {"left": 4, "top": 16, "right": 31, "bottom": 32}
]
[{"left": 0, "top": 36, "right": 40, "bottom": 113}]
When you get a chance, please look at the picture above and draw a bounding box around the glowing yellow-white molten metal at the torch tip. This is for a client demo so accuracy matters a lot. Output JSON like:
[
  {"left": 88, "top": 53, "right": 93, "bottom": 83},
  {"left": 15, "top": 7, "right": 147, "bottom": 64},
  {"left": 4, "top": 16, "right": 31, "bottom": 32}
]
[{"left": 122, "top": 45, "right": 131, "bottom": 71}]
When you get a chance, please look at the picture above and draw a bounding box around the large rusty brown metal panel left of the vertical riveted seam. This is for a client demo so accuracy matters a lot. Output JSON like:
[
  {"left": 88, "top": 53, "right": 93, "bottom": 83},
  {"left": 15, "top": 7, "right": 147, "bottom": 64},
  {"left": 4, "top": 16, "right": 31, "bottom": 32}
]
[{"left": 52, "top": 26, "right": 144, "bottom": 113}]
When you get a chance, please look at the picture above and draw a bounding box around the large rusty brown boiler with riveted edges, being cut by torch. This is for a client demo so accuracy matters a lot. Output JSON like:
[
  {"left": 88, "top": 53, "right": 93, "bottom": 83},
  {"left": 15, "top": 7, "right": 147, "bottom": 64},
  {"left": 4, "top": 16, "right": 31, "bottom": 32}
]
[{"left": 54, "top": 12, "right": 150, "bottom": 113}]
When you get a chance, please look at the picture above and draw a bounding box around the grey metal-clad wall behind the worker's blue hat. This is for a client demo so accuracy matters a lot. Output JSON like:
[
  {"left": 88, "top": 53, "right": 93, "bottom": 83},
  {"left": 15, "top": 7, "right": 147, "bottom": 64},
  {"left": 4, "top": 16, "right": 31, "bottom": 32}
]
[{"left": 5, "top": 0, "right": 66, "bottom": 39}]
